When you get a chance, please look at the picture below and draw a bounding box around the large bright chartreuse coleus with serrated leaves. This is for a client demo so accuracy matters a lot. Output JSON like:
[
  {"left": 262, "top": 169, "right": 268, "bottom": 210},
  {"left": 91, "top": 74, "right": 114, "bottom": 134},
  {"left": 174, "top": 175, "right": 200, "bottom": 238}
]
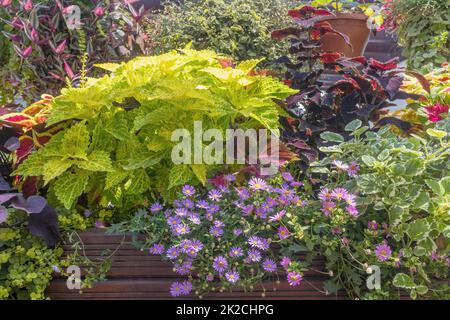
[{"left": 15, "top": 48, "right": 295, "bottom": 208}]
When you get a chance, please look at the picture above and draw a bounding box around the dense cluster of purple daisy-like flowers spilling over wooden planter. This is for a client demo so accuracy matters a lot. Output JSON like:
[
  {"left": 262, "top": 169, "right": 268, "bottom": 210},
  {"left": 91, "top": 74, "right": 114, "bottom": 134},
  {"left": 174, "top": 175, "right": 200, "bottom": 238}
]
[{"left": 142, "top": 172, "right": 308, "bottom": 296}]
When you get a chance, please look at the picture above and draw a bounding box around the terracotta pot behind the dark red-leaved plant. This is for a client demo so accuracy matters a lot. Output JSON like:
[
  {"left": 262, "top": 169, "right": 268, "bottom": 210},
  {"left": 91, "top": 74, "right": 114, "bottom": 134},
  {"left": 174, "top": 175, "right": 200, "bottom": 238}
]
[{"left": 321, "top": 13, "right": 370, "bottom": 58}]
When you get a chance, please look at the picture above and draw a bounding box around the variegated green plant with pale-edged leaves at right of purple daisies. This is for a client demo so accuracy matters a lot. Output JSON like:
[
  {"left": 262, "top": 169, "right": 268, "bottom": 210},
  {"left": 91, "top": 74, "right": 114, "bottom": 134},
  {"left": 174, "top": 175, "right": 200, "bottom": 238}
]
[{"left": 292, "top": 120, "right": 450, "bottom": 299}]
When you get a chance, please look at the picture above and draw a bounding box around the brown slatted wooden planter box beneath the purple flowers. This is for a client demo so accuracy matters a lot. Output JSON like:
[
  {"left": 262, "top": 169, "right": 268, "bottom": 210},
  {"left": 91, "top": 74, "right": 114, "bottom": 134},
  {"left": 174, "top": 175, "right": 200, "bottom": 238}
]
[{"left": 47, "top": 229, "right": 345, "bottom": 300}]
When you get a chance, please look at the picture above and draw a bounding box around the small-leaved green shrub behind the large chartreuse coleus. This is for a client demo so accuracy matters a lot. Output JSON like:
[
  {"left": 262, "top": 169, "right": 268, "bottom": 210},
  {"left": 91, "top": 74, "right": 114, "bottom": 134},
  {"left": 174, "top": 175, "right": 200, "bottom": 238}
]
[{"left": 147, "top": 0, "right": 295, "bottom": 65}]
